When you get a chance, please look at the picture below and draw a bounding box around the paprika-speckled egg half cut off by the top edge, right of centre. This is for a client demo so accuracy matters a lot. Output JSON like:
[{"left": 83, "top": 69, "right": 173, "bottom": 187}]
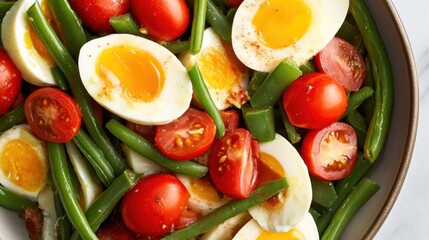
[{"left": 232, "top": 0, "right": 349, "bottom": 72}]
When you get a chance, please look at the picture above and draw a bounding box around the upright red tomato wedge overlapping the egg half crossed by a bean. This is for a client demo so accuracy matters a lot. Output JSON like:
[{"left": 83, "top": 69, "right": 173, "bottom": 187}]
[{"left": 209, "top": 128, "right": 259, "bottom": 198}]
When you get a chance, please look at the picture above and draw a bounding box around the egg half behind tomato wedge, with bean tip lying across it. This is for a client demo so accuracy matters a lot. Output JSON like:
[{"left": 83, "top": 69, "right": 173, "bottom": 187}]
[{"left": 249, "top": 134, "right": 312, "bottom": 232}]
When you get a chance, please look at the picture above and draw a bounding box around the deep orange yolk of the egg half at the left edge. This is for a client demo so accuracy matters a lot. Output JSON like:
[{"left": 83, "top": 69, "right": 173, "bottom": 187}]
[{"left": 0, "top": 139, "right": 46, "bottom": 192}]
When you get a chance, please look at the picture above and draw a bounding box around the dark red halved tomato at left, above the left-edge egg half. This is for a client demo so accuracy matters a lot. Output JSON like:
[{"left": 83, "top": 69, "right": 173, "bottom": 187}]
[{"left": 24, "top": 87, "right": 82, "bottom": 143}]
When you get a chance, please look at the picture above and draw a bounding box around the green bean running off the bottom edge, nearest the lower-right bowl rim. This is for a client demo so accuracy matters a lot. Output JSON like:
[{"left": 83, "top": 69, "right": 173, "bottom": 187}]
[{"left": 321, "top": 178, "right": 380, "bottom": 240}]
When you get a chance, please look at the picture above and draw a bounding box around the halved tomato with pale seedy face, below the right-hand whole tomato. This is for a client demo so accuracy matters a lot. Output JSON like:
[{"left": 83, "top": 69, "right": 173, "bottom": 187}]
[{"left": 301, "top": 122, "right": 357, "bottom": 181}]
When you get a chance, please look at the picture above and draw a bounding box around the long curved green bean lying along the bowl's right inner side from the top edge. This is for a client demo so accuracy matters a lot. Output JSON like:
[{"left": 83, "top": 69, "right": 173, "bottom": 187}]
[{"left": 349, "top": 0, "right": 394, "bottom": 162}]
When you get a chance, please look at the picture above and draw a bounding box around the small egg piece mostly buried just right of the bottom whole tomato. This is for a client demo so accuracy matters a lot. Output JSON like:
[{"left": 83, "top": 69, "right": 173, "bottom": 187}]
[{"left": 177, "top": 174, "right": 231, "bottom": 215}]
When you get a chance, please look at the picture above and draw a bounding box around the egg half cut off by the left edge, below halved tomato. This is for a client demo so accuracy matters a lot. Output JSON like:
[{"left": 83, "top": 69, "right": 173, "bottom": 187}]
[{"left": 0, "top": 124, "right": 48, "bottom": 200}]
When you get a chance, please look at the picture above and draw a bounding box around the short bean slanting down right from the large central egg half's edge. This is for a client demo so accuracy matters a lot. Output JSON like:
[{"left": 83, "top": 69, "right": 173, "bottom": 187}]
[{"left": 188, "top": 65, "right": 225, "bottom": 137}]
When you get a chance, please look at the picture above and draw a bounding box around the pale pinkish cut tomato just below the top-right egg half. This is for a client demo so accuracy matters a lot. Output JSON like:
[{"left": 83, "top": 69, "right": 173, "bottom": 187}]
[{"left": 314, "top": 37, "right": 366, "bottom": 91}]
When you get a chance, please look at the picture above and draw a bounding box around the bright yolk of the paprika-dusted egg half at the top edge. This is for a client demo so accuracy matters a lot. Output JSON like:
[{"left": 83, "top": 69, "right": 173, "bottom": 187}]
[{"left": 252, "top": 0, "right": 312, "bottom": 49}]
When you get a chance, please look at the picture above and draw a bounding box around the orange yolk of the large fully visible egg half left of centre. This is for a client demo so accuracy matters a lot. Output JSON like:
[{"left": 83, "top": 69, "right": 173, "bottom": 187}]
[{"left": 96, "top": 45, "right": 165, "bottom": 102}]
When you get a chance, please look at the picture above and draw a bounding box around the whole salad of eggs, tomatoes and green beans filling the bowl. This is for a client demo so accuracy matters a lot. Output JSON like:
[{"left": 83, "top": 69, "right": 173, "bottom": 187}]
[{"left": 0, "top": 0, "right": 393, "bottom": 240}]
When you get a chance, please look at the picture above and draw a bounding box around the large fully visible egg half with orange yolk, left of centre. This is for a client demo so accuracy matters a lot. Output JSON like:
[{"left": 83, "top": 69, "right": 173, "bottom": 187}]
[{"left": 79, "top": 34, "right": 192, "bottom": 125}]
